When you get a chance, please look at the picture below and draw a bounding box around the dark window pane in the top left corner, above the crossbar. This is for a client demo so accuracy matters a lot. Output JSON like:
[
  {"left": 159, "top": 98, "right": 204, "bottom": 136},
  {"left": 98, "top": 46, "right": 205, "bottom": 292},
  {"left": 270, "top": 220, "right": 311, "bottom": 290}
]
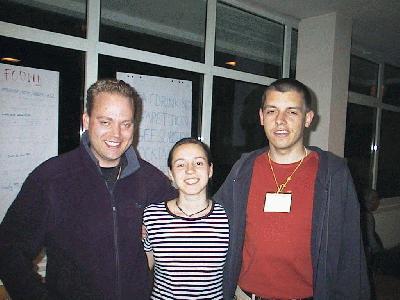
[{"left": 0, "top": 0, "right": 86, "bottom": 37}]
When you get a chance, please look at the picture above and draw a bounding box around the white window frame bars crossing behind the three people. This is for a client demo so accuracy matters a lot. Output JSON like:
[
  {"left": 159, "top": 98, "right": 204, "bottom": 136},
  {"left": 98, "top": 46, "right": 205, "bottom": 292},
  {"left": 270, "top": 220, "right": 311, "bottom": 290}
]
[{"left": 0, "top": 0, "right": 298, "bottom": 143}]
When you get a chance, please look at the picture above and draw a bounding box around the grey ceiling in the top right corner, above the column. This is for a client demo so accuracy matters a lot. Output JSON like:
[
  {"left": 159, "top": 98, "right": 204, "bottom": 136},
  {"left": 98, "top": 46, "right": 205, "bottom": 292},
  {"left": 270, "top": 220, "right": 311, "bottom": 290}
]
[{"left": 248, "top": 0, "right": 400, "bottom": 66}]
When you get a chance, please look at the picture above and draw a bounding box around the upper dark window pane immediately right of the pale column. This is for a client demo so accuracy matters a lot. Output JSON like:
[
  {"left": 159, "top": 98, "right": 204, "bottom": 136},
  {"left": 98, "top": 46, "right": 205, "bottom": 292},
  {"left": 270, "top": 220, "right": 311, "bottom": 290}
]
[{"left": 349, "top": 55, "right": 379, "bottom": 97}]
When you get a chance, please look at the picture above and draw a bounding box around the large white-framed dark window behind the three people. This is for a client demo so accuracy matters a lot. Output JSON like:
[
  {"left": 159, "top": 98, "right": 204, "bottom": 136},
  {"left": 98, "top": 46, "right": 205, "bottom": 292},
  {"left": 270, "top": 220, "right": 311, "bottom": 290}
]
[{"left": 0, "top": 0, "right": 297, "bottom": 191}]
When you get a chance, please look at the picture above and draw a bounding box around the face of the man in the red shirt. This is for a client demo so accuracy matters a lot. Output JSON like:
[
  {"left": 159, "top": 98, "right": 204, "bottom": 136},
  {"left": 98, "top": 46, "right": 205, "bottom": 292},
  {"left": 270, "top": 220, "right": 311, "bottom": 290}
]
[{"left": 259, "top": 90, "right": 314, "bottom": 153}]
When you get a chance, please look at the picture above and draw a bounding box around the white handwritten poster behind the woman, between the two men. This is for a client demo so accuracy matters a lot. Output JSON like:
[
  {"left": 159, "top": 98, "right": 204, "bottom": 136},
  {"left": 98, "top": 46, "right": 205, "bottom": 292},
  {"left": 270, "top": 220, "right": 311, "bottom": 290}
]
[{"left": 117, "top": 72, "right": 192, "bottom": 173}]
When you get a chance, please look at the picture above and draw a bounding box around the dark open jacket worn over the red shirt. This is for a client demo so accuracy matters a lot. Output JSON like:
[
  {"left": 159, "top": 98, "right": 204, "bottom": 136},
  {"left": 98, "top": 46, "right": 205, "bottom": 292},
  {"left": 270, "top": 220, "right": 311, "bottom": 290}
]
[{"left": 214, "top": 147, "right": 370, "bottom": 300}]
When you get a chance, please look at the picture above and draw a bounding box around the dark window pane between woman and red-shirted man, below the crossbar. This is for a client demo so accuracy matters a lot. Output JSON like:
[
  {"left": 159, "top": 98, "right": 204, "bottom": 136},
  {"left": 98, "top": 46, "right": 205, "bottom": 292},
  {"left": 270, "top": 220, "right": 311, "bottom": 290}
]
[{"left": 211, "top": 77, "right": 267, "bottom": 192}]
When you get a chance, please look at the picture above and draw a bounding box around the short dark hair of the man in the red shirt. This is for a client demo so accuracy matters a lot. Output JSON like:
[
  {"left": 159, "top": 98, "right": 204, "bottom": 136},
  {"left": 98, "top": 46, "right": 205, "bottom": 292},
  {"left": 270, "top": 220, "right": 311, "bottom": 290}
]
[{"left": 261, "top": 78, "right": 311, "bottom": 111}]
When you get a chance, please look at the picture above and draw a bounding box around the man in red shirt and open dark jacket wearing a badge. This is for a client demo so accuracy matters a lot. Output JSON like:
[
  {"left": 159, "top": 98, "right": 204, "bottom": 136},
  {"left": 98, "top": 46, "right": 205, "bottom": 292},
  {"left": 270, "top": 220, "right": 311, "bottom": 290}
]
[{"left": 214, "top": 79, "right": 370, "bottom": 300}]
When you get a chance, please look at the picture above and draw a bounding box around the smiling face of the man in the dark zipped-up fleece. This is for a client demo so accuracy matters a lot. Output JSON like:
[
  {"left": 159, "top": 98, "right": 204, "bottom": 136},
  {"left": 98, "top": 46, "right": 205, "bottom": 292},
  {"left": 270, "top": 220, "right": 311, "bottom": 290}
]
[{"left": 83, "top": 93, "right": 134, "bottom": 167}]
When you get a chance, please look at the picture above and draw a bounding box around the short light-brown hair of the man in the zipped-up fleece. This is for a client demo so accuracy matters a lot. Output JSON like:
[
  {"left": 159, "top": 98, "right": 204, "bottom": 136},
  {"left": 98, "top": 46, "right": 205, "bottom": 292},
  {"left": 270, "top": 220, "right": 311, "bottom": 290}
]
[{"left": 86, "top": 78, "right": 139, "bottom": 116}]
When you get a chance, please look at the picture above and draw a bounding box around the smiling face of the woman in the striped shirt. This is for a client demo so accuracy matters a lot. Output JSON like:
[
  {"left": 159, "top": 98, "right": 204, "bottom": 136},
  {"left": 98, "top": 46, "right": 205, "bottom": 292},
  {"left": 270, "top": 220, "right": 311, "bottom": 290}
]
[{"left": 169, "top": 143, "right": 213, "bottom": 196}]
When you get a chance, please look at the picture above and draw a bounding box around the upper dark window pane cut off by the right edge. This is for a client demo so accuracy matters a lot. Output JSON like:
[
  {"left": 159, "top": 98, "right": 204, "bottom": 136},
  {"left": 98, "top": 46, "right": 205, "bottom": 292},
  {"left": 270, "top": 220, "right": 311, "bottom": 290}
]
[{"left": 382, "top": 65, "right": 400, "bottom": 106}]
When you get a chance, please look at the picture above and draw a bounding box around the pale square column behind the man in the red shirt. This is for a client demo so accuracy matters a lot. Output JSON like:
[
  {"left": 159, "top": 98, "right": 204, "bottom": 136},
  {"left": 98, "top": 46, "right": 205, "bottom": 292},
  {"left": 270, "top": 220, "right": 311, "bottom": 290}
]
[{"left": 296, "top": 13, "right": 352, "bottom": 156}]
